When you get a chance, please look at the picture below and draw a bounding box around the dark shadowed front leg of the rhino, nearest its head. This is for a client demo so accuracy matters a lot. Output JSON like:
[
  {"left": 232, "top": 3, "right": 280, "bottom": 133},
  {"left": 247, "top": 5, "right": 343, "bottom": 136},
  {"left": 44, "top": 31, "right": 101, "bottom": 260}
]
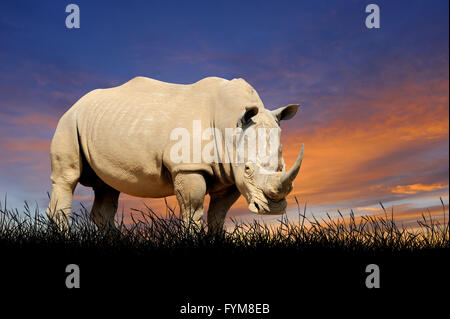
[{"left": 208, "top": 185, "right": 241, "bottom": 234}]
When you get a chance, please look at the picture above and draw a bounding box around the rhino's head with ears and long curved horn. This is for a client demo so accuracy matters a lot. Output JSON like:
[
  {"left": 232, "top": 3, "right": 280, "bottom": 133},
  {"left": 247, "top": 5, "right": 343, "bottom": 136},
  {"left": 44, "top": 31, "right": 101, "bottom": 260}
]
[{"left": 233, "top": 104, "right": 303, "bottom": 215}]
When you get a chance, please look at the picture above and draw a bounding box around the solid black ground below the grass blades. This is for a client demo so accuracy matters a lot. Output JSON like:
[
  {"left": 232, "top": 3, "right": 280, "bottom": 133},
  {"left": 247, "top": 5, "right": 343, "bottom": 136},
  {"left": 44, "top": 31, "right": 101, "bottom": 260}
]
[{"left": 0, "top": 245, "right": 450, "bottom": 318}]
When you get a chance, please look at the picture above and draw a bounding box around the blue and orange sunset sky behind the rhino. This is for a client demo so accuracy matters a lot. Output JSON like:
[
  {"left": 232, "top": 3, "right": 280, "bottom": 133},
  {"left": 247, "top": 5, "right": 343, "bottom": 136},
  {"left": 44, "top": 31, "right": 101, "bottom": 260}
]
[{"left": 0, "top": 0, "right": 449, "bottom": 229}]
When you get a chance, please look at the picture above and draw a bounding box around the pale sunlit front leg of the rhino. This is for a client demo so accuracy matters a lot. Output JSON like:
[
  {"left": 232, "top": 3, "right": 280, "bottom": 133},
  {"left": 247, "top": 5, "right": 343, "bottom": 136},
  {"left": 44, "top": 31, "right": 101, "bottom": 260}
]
[{"left": 173, "top": 172, "right": 206, "bottom": 228}]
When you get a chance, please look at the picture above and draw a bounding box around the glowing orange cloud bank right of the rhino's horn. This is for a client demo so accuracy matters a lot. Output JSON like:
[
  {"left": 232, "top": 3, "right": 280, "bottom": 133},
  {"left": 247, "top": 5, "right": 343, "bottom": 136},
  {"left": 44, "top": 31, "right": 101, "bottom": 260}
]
[{"left": 282, "top": 65, "right": 449, "bottom": 215}]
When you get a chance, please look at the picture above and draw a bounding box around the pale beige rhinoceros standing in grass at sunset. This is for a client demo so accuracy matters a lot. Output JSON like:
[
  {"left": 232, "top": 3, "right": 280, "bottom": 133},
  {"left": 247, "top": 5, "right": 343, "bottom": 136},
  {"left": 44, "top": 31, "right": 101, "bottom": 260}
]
[{"left": 46, "top": 77, "right": 303, "bottom": 231}]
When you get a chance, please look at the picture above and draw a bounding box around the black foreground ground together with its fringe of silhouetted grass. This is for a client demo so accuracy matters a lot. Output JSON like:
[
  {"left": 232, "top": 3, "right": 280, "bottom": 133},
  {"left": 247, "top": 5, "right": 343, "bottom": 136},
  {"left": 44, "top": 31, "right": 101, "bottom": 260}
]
[{"left": 0, "top": 202, "right": 450, "bottom": 319}]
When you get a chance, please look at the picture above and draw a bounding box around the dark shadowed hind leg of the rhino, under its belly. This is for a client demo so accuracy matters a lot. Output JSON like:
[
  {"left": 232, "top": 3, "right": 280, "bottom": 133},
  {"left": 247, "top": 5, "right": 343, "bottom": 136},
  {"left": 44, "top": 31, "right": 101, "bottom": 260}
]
[{"left": 90, "top": 183, "right": 120, "bottom": 233}]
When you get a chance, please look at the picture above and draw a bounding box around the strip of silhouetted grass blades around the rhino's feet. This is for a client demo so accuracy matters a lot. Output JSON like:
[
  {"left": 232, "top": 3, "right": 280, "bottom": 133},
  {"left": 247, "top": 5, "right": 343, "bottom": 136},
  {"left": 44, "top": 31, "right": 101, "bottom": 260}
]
[{"left": 0, "top": 199, "right": 449, "bottom": 255}]
